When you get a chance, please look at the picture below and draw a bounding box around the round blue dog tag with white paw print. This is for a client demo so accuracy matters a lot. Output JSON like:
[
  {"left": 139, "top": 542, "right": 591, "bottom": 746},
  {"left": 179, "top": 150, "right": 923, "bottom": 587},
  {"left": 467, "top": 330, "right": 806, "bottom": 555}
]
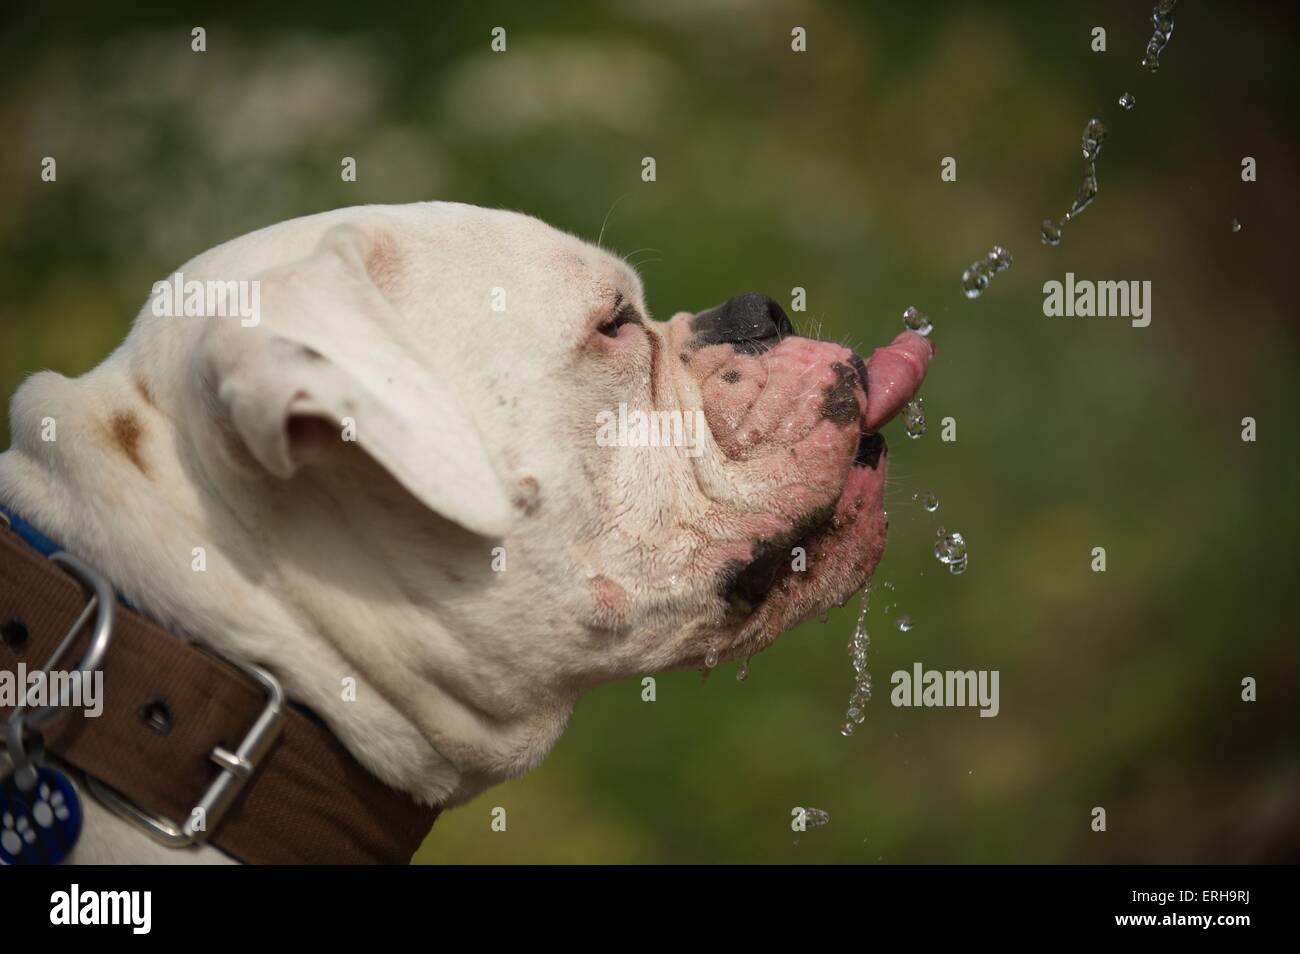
[{"left": 0, "top": 766, "right": 82, "bottom": 864}]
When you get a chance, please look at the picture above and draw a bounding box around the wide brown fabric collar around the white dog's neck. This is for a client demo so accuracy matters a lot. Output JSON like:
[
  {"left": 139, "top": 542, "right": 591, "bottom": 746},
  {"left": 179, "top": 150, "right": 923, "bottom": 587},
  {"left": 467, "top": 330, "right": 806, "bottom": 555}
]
[{"left": 0, "top": 519, "right": 439, "bottom": 864}]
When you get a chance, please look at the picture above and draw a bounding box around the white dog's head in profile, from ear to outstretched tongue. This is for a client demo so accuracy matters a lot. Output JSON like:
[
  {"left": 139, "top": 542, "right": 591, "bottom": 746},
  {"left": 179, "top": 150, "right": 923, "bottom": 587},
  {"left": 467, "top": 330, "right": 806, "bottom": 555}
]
[{"left": 191, "top": 203, "right": 931, "bottom": 790}]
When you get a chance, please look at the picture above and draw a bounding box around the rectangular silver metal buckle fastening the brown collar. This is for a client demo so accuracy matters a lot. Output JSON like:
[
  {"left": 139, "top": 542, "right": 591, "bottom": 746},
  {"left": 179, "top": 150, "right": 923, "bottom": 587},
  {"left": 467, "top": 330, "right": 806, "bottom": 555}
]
[{"left": 85, "top": 652, "right": 285, "bottom": 847}]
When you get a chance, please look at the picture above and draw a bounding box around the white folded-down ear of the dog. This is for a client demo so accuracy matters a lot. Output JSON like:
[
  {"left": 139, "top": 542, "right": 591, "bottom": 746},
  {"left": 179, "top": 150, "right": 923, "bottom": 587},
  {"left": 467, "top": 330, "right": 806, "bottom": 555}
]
[{"left": 200, "top": 225, "right": 514, "bottom": 537}]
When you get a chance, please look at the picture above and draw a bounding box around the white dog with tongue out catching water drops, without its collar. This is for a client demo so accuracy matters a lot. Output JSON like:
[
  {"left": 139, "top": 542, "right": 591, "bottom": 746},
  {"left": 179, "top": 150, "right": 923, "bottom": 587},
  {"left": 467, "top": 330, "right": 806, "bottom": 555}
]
[{"left": 0, "top": 203, "right": 932, "bottom": 863}]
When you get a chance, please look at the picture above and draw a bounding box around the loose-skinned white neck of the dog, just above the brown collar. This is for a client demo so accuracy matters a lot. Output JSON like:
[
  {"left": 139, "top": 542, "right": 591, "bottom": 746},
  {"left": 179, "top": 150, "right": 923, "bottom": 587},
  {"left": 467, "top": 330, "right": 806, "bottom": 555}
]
[{"left": 0, "top": 353, "right": 573, "bottom": 821}]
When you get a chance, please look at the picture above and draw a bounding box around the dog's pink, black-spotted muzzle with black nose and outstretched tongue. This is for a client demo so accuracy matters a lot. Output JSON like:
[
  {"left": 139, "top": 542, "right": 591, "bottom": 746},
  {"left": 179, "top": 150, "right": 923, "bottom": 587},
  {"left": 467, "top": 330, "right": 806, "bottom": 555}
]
[{"left": 668, "top": 294, "right": 932, "bottom": 658}]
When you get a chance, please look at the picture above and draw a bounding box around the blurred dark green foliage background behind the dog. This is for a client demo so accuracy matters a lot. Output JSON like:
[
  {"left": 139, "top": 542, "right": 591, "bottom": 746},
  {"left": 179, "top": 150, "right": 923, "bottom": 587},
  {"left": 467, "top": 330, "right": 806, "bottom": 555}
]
[{"left": 0, "top": 0, "right": 1300, "bottom": 862}]
